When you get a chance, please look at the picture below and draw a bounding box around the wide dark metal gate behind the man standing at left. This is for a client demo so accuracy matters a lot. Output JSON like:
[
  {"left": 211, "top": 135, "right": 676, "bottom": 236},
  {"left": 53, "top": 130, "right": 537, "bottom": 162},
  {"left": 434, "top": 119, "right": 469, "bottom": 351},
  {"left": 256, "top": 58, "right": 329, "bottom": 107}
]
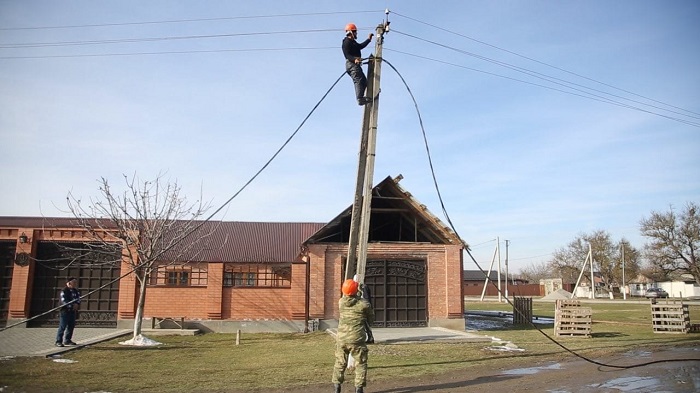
[{"left": 29, "top": 242, "right": 121, "bottom": 327}]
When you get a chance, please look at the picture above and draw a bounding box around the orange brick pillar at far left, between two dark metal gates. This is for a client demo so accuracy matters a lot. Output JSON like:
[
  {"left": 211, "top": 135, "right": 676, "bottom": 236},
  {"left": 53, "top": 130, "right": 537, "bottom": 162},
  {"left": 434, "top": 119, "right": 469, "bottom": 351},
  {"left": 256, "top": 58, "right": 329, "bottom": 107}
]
[{"left": 8, "top": 228, "right": 36, "bottom": 319}]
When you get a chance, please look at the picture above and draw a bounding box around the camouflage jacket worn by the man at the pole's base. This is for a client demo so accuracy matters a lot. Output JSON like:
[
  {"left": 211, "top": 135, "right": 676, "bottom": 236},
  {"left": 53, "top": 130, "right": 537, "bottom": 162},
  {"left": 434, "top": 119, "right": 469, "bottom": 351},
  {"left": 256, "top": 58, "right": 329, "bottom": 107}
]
[{"left": 338, "top": 296, "right": 374, "bottom": 344}]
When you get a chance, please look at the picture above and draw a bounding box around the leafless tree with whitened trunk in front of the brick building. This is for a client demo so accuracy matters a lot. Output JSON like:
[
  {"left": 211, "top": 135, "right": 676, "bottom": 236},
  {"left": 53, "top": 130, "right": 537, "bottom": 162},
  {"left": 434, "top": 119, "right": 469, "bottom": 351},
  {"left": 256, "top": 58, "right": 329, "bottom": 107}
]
[{"left": 67, "top": 174, "right": 211, "bottom": 338}]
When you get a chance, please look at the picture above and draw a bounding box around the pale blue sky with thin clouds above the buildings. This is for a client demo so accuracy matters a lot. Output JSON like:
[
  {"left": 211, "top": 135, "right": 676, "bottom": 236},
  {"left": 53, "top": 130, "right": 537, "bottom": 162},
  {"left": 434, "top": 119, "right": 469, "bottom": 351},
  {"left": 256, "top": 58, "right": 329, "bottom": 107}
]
[{"left": 0, "top": 0, "right": 700, "bottom": 271}]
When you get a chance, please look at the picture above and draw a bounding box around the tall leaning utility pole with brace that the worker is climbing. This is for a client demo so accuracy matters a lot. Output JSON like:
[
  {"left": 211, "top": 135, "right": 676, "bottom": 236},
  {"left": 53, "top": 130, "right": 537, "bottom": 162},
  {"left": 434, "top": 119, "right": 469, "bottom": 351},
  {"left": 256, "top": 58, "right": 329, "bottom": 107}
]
[{"left": 345, "top": 16, "right": 389, "bottom": 283}]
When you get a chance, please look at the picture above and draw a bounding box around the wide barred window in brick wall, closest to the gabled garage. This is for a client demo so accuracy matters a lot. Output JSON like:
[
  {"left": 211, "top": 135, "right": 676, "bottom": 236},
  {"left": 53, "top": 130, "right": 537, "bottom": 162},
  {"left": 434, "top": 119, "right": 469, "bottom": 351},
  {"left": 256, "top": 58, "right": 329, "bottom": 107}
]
[{"left": 224, "top": 263, "right": 292, "bottom": 288}]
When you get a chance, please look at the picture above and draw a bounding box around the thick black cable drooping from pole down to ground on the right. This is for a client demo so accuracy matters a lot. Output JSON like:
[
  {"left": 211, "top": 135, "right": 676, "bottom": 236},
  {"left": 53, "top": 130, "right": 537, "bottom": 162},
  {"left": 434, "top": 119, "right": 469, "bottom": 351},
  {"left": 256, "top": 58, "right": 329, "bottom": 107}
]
[{"left": 379, "top": 58, "right": 700, "bottom": 369}]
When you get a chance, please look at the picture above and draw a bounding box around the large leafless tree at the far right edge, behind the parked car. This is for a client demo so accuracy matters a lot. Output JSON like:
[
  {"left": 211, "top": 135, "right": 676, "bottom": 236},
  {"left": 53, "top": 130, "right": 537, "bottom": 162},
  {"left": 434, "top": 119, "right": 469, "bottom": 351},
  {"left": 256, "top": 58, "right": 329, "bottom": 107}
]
[{"left": 640, "top": 202, "right": 700, "bottom": 285}]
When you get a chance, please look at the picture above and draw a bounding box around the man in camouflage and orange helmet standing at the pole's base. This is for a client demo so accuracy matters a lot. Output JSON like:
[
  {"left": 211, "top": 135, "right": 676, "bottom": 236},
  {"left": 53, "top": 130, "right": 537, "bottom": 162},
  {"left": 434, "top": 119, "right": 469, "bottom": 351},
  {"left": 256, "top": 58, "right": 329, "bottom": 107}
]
[{"left": 333, "top": 280, "right": 374, "bottom": 393}]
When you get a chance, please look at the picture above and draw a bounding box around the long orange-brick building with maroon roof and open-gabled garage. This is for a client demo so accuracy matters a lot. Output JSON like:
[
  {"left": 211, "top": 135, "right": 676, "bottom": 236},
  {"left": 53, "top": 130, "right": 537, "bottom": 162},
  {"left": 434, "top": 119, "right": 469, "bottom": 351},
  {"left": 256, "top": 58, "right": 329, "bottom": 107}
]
[{"left": 0, "top": 177, "right": 464, "bottom": 332}]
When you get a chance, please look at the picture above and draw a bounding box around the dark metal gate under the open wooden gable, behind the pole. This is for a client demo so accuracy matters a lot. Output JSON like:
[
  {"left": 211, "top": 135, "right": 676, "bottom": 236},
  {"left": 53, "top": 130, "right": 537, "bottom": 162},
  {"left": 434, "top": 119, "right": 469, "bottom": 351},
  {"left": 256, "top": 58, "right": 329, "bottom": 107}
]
[{"left": 365, "top": 259, "right": 428, "bottom": 327}]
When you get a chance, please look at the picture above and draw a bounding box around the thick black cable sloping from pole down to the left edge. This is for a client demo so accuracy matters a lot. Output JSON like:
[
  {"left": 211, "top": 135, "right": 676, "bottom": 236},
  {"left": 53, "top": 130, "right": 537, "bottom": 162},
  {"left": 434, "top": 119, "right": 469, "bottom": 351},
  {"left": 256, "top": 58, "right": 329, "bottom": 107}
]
[{"left": 0, "top": 72, "right": 345, "bottom": 332}]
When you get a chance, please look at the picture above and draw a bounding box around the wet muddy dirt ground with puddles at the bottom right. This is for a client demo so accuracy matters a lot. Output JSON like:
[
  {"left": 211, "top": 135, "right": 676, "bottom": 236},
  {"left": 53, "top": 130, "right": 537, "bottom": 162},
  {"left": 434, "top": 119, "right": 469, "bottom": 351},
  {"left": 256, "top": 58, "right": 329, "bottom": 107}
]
[{"left": 279, "top": 343, "right": 700, "bottom": 393}]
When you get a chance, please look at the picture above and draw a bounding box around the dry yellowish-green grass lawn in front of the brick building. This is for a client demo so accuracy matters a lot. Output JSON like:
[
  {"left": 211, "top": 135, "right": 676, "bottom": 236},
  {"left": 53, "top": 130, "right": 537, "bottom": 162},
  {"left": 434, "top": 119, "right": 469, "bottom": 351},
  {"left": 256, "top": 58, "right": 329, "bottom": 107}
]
[{"left": 0, "top": 302, "right": 700, "bottom": 392}]
